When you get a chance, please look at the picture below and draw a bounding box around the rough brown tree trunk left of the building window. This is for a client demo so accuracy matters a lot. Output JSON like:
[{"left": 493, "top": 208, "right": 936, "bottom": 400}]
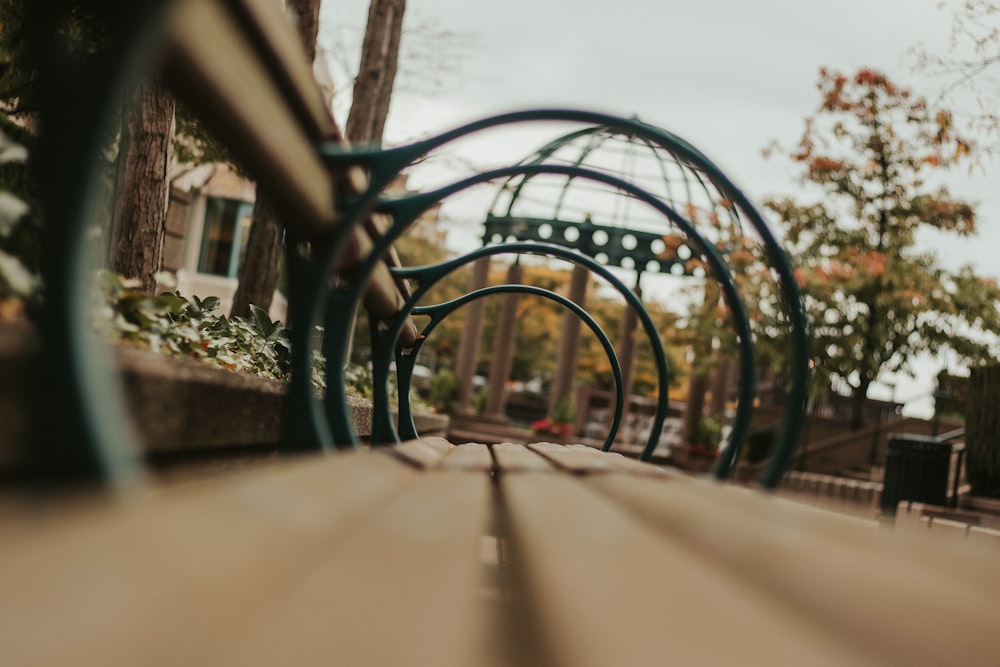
[{"left": 108, "top": 82, "right": 174, "bottom": 294}]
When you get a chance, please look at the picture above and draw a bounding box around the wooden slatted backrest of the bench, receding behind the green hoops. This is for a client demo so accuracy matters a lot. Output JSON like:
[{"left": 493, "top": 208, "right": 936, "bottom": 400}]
[{"left": 168, "top": 0, "right": 417, "bottom": 347}]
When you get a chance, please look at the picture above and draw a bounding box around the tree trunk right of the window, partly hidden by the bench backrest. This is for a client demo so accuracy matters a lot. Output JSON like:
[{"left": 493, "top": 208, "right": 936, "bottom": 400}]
[{"left": 229, "top": 0, "right": 320, "bottom": 317}]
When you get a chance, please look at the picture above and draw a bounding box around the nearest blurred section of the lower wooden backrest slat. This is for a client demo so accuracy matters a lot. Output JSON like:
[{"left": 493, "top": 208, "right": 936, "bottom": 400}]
[{"left": 167, "top": 0, "right": 336, "bottom": 237}]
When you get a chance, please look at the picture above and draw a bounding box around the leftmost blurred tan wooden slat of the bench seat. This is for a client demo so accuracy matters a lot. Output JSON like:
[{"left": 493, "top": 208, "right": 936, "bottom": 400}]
[{"left": 0, "top": 452, "right": 419, "bottom": 667}]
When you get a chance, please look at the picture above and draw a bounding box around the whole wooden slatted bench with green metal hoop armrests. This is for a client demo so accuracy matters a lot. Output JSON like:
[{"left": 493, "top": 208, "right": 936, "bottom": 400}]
[{"left": 7, "top": 0, "right": 1000, "bottom": 666}]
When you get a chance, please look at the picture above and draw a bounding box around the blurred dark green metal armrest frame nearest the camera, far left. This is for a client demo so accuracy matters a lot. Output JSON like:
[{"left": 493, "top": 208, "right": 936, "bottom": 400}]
[{"left": 32, "top": 0, "right": 175, "bottom": 492}]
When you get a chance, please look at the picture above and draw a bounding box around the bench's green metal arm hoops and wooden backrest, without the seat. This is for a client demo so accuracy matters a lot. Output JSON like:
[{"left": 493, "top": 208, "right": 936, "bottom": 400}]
[{"left": 31, "top": 1, "right": 808, "bottom": 488}]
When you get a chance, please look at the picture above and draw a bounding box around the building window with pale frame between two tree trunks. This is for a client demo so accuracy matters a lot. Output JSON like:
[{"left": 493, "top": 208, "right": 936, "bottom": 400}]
[{"left": 198, "top": 197, "right": 253, "bottom": 278}]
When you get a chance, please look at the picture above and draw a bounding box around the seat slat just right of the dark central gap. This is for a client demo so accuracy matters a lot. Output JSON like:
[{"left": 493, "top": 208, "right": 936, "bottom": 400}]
[{"left": 500, "top": 473, "right": 867, "bottom": 667}]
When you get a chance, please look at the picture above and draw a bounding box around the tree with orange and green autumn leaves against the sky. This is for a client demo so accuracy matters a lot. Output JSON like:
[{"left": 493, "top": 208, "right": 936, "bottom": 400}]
[{"left": 766, "top": 69, "right": 1000, "bottom": 427}]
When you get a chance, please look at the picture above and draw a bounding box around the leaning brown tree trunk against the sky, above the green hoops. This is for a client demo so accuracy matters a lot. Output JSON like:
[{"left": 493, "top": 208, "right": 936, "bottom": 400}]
[{"left": 346, "top": 0, "right": 406, "bottom": 143}]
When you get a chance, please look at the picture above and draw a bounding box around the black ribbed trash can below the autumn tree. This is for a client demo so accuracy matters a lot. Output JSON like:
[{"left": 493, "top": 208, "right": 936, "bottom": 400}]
[{"left": 880, "top": 435, "right": 951, "bottom": 518}]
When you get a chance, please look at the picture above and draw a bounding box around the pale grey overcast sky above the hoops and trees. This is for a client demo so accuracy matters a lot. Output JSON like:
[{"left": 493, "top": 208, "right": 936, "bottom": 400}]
[{"left": 321, "top": 0, "right": 1000, "bottom": 414}]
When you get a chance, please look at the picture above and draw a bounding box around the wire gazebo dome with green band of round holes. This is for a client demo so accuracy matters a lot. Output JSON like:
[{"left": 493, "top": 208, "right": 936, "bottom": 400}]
[{"left": 483, "top": 120, "right": 741, "bottom": 275}]
